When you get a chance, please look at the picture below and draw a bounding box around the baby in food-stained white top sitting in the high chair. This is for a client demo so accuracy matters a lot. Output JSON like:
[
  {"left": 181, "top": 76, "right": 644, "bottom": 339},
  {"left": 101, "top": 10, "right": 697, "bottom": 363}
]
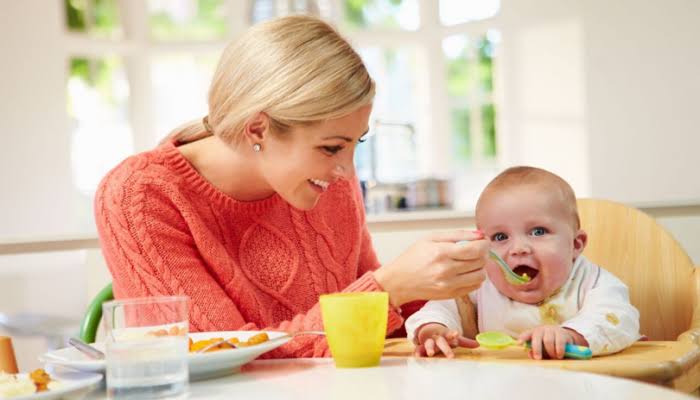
[{"left": 406, "top": 167, "right": 640, "bottom": 360}]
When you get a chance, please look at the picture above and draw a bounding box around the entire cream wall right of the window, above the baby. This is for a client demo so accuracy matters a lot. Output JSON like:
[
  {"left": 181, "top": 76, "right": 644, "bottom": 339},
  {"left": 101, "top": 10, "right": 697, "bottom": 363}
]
[{"left": 499, "top": 0, "right": 700, "bottom": 203}]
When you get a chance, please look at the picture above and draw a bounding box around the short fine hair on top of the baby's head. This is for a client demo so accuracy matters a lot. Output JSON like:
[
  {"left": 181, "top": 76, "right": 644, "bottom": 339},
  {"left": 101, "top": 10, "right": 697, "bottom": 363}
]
[{"left": 476, "top": 166, "right": 581, "bottom": 230}]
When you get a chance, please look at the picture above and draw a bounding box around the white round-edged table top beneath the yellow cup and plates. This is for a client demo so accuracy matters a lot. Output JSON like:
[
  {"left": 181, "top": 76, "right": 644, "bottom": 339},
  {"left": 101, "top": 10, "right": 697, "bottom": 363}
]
[{"left": 88, "top": 357, "right": 692, "bottom": 400}]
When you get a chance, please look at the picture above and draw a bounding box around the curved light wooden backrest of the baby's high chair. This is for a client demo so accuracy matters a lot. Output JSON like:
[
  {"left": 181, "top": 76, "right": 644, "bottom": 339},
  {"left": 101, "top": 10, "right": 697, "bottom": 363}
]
[{"left": 578, "top": 199, "right": 700, "bottom": 343}]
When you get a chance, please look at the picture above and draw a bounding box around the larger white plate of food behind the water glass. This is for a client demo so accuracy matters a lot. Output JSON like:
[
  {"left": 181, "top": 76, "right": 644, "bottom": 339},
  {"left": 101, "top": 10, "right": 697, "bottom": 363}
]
[{"left": 39, "top": 331, "right": 291, "bottom": 380}]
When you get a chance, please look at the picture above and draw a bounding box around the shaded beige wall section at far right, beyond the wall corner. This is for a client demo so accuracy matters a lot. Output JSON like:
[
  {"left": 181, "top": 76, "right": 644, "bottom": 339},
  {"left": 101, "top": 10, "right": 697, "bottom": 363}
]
[{"left": 583, "top": 0, "right": 700, "bottom": 202}]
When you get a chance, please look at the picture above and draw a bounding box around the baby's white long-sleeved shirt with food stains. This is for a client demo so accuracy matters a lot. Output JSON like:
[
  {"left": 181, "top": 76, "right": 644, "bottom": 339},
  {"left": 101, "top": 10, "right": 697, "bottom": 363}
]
[{"left": 406, "top": 256, "right": 640, "bottom": 355}]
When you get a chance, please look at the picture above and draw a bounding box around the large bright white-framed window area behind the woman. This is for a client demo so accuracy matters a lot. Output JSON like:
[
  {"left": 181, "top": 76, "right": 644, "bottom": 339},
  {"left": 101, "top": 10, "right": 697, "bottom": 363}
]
[{"left": 56, "top": 0, "right": 500, "bottom": 234}]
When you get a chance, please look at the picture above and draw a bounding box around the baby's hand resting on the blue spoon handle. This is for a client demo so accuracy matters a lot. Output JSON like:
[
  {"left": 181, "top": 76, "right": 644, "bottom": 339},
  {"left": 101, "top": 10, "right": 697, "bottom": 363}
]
[{"left": 518, "top": 325, "right": 588, "bottom": 360}]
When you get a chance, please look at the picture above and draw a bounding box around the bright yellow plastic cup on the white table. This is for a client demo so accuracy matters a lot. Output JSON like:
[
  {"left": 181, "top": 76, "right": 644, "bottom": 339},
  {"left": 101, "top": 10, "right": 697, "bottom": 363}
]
[{"left": 320, "top": 292, "right": 389, "bottom": 368}]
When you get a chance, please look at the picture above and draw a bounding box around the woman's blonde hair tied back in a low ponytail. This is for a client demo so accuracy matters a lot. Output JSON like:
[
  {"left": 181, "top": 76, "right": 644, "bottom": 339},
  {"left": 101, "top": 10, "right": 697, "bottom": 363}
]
[{"left": 164, "top": 15, "right": 375, "bottom": 147}]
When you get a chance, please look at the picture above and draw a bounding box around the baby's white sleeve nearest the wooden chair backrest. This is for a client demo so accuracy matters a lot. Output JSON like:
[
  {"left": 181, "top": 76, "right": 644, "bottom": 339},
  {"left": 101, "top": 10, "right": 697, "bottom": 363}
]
[{"left": 562, "top": 268, "right": 640, "bottom": 356}]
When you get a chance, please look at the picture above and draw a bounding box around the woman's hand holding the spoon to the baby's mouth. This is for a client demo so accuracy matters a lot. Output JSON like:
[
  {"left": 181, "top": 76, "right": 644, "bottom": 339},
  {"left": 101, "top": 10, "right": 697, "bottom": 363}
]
[{"left": 374, "top": 230, "right": 489, "bottom": 307}]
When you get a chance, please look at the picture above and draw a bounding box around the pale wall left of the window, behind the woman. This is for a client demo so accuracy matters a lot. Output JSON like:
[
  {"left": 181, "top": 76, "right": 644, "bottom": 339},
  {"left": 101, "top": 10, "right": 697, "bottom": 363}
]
[{"left": 0, "top": 0, "right": 81, "bottom": 238}]
